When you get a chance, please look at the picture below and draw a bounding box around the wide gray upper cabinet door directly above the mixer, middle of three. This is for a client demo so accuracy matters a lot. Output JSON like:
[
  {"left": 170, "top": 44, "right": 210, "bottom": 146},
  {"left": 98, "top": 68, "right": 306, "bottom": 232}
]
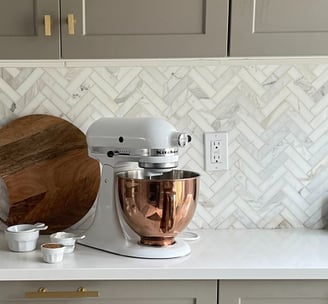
[{"left": 61, "top": 0, "right": 228, "bottom": 59}]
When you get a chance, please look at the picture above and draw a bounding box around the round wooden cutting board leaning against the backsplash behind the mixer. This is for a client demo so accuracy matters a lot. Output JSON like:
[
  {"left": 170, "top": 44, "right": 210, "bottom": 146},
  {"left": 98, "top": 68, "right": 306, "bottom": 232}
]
[{"left": 0, "top": 115, "right": 100, "bottom": 234}]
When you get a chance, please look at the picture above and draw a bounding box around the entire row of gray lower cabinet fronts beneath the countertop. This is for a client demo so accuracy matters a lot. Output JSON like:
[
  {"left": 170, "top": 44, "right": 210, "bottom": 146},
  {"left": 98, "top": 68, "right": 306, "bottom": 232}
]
[{"left": 4, "top": 280, "right": 328, "bottom": 304}]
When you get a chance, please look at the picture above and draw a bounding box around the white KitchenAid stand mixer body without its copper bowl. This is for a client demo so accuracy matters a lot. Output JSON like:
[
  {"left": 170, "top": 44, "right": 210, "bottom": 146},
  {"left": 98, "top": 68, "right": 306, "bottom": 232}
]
[{"left": 79, "top": 118, "right": 199, "bottom": 259}]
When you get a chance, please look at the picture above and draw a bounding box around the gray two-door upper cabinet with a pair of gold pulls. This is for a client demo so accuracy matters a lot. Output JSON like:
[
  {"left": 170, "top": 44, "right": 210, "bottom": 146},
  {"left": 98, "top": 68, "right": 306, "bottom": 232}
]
[{"left": 0, "top": 0, "right": 229, "bottom": 60}]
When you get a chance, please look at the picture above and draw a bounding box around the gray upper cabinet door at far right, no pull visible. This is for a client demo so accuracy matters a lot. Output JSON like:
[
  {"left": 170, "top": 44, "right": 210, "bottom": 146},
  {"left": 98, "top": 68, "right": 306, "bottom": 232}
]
[{"left": 229, "top": 0, "right": 328, "bottom": 56}]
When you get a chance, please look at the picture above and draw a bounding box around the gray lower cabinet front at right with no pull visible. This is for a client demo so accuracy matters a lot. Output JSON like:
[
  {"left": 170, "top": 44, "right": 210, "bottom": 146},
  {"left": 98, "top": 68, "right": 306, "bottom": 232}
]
[{"left": 219, "top": 280, "right": 328, "bottom": 304}]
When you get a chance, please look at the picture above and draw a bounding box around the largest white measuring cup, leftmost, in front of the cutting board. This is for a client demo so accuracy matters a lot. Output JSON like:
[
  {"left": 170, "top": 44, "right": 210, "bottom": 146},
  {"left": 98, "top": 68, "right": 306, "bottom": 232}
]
[{"left": 5, "top": 224, "right": 46, "bottom": 252}]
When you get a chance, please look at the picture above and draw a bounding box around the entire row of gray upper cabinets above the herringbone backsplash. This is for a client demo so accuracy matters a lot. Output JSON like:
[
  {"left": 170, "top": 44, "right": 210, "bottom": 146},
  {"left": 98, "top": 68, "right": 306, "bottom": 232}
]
[{"left": 5, "top": 0, "right": 328, "bottom": 60}]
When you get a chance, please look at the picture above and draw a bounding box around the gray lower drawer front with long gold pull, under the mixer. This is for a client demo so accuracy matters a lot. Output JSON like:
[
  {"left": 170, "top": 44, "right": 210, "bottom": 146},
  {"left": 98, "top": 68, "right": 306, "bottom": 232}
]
[{"left": 0, "top": 280, "right": 217, "bottom": 304}]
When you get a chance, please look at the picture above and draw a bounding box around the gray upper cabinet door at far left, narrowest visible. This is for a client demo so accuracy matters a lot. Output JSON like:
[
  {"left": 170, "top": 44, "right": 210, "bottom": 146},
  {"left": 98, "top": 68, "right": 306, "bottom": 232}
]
[{"left": 0, "top": 0, "right": 60, "bottom": 59}]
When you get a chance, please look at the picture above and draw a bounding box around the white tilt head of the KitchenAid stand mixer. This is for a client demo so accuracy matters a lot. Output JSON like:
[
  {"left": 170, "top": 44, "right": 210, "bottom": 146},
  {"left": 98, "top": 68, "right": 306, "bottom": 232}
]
[{"left": 87, "top": 118, "right": 191, "bottom": 175}]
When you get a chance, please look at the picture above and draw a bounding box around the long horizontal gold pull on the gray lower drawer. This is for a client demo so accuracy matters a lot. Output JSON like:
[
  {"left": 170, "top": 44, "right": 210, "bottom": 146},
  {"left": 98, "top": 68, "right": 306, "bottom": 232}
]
[{"left": 25, "top": 287, "right": 99, "bottom": 298}]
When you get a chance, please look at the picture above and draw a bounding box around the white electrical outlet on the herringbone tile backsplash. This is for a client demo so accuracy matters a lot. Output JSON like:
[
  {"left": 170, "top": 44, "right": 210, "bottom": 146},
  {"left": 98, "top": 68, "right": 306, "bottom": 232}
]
[{"left": 204, "top": 132, "right": 228, "bottom": 171}]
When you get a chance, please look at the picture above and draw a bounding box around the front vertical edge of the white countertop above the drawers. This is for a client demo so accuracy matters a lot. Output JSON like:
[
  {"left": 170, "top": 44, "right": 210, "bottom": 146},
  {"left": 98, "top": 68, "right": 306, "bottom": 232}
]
[{"left": 0, "top": 269, "right": 328, "bottom": 281}]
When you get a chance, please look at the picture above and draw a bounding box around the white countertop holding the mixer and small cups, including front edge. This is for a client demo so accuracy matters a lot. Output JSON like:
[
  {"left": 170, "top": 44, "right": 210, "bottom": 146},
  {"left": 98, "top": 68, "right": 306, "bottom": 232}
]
[{"left": 0, "top": 229, "right": 328, "bottom": 281}]
